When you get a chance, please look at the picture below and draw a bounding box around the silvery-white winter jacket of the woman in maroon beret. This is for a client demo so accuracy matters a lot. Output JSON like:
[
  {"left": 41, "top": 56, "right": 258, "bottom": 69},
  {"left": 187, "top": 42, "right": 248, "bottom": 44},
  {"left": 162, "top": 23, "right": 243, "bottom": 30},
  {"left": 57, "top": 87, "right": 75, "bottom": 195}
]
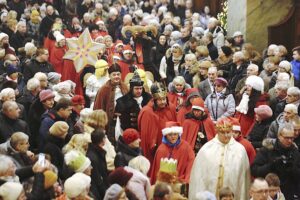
[{"left": 204, "top": 88, "right": 235, "bottom": 121}]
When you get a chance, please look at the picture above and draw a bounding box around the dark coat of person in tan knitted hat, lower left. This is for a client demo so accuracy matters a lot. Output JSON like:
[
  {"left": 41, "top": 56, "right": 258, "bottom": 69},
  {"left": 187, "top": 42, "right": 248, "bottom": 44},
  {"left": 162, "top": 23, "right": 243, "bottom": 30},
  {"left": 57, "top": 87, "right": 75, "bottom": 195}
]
[{"left": 43, "top": 135, "right": 65, "bottom": 178}]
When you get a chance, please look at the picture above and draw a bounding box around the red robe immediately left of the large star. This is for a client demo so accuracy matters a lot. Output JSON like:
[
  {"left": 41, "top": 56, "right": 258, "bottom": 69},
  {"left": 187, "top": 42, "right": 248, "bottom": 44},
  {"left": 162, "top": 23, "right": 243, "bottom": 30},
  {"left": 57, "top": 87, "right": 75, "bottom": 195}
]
[{"left": 49, "top": 45, "right": 66, "bottom": 74}]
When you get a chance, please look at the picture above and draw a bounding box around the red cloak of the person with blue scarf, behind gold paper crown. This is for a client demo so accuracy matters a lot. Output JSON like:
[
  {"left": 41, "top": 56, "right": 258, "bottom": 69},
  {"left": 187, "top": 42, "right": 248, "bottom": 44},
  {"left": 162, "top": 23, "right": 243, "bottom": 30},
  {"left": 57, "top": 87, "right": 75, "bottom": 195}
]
[{"left": 151, "top": 140, "right": 195, "bottom": 184}]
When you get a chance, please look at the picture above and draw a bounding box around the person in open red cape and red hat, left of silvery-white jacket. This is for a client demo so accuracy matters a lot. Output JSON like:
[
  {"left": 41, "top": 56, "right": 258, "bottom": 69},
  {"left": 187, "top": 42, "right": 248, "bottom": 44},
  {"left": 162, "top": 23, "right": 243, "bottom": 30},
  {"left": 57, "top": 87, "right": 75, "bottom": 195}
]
[{"left": 182, "top": 98, "right": 216, "bottom": 153}]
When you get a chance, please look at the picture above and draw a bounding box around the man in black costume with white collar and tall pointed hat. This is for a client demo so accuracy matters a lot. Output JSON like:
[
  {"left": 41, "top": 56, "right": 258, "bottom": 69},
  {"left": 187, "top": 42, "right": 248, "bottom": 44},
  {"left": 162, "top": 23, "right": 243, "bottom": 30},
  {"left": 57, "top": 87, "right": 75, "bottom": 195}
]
[{"left": 115, "top": 71, "right": 151, "bottom": 130}]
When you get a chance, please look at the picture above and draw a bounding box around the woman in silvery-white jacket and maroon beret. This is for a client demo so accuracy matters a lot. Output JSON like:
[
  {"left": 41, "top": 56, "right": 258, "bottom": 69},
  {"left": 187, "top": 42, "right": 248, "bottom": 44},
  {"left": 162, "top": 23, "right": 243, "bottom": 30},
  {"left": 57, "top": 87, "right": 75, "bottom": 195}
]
[{"left": 205, "top": 78, "right": 235, "bottom": 121}]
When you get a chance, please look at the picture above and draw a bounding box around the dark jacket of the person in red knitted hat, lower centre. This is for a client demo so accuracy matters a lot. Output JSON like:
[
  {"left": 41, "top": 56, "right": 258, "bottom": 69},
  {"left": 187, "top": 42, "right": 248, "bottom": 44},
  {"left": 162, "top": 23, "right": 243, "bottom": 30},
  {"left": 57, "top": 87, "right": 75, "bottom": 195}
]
[{"left": 114, "top": 136, "right": 142, "bottom": 168}]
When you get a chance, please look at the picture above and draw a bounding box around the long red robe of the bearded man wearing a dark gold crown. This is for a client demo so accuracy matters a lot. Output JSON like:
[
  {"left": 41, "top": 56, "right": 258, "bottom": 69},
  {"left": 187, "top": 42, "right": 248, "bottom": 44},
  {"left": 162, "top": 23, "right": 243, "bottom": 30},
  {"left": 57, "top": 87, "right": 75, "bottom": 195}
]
[{"left": 138, "top": 100, "right": 176, "bottom": 163}]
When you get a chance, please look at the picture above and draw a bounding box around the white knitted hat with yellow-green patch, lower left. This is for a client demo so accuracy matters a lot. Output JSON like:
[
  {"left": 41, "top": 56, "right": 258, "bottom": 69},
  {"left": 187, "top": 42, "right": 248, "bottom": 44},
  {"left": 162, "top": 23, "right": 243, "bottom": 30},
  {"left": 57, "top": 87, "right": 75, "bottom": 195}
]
[{"left": 65, "top": 150, "right": 91, "bottom": 172}]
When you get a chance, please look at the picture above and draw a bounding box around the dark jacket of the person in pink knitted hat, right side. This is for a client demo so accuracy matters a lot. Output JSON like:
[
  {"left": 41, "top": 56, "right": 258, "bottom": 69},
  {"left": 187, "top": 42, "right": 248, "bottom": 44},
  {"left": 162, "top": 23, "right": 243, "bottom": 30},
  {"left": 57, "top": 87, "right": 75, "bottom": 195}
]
[{"left": 248, "top": 120, "right": 271, "bottom": 149}]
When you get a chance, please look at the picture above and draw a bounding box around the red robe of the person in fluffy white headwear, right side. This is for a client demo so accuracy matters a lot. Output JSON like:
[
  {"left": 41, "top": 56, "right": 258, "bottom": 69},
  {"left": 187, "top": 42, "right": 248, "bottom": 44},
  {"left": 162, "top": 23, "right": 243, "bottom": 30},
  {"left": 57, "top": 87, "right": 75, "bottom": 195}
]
[{"left": 237, "top": 94, "right": 269, "bottom": 137}]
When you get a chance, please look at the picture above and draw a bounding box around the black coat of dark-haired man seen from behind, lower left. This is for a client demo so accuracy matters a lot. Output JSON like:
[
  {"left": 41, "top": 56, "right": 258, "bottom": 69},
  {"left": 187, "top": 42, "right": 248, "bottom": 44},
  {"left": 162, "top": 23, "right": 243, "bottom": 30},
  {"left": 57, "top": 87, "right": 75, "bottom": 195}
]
[{"left": 87, "top": 144, "right": 109, "bottom": 200}]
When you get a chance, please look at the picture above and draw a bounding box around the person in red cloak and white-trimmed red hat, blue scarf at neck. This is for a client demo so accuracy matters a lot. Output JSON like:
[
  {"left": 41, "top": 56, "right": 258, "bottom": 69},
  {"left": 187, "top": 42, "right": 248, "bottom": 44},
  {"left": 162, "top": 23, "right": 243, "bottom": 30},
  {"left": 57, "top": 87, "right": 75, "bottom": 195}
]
[{"left": 151, "top": 121, "right": 195, "bottom": 184}]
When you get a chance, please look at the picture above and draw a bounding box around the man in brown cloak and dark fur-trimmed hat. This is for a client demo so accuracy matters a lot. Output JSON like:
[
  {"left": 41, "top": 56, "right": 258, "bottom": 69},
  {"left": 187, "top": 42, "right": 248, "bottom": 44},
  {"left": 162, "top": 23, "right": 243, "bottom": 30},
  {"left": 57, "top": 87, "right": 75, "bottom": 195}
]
[{"left": 94, "top": 64, "right": 128, "bottom": 143}]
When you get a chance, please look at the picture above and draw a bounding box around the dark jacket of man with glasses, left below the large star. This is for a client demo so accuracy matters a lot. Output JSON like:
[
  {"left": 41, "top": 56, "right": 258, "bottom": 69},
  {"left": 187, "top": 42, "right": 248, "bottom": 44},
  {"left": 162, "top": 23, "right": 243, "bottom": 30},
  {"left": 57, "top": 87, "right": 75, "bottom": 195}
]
[{"left": 24, "top": 59, "right": 54, "bottom": 83}]
